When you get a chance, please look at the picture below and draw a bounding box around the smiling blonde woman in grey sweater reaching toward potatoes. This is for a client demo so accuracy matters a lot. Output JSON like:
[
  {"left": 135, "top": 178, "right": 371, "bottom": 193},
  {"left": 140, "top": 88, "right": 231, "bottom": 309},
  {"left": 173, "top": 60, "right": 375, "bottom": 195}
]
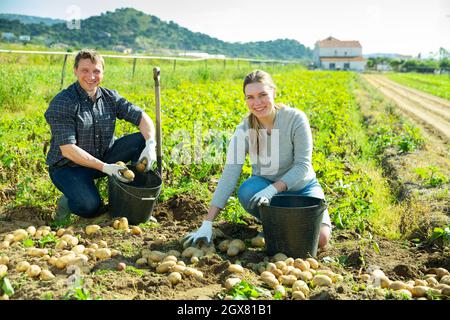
[{"left": 185, "top": 70, "right": 331, "bottom": 247}]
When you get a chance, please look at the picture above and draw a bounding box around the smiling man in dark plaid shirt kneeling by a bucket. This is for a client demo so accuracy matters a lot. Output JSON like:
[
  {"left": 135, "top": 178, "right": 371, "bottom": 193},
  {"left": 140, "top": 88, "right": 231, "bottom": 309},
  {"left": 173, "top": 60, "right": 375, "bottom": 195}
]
[{"left": 45, "top": 50, "right": 156, "bottom": 222}]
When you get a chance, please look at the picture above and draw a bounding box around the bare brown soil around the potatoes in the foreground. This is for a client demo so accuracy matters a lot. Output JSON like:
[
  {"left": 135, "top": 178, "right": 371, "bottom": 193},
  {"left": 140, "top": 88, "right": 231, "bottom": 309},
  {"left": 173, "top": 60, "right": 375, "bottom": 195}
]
[{"left": 0, "top": 191, "right": 450, "bottom": 300}]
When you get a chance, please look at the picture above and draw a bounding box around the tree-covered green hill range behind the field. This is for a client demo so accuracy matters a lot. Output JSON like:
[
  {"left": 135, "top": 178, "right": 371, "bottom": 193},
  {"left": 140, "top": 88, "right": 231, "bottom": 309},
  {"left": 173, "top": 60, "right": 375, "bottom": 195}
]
[{"left": 0, "top": 8, "right": 312, "bottom": 60}]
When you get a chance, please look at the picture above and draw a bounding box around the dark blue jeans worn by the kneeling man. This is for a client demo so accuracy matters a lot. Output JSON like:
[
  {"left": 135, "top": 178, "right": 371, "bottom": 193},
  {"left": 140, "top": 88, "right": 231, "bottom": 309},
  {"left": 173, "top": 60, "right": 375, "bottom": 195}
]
[{"left": 49, "top": 132, "right": 145, "bottom": 218}]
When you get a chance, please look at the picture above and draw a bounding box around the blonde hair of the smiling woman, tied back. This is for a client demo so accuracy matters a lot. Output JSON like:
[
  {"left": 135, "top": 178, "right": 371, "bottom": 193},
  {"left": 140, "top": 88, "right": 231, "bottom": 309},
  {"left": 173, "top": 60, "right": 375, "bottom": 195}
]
[{"left": 243, "top": 70, "right": 284, "bottom": 155}]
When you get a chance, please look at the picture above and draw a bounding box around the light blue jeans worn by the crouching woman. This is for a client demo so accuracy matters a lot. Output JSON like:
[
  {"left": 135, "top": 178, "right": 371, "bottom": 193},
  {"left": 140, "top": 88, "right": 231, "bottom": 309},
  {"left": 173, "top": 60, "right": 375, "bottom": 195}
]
[{"left": 238, "top": 176, "right": 331, "bottom": 228}]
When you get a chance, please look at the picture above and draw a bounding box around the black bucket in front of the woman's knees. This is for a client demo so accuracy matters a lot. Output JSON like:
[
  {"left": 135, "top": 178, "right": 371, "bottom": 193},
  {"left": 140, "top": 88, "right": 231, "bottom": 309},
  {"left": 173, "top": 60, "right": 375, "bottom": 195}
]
[{"left": 259, "top": 195, "right": 326, "bottom": 258}]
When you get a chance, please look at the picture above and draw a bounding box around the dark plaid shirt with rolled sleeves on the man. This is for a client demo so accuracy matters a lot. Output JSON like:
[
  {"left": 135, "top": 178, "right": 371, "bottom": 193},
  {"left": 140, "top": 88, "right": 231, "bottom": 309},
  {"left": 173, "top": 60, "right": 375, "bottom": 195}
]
[{"left": 45, "top": 81, "right": 143, "bottom": 167}]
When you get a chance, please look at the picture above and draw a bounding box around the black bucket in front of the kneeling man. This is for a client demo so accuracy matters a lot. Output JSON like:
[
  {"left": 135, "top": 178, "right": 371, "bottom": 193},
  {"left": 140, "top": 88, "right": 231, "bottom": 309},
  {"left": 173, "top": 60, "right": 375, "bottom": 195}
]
[{"left": 108, "top": 165, "right": 162, "bottom": 225}]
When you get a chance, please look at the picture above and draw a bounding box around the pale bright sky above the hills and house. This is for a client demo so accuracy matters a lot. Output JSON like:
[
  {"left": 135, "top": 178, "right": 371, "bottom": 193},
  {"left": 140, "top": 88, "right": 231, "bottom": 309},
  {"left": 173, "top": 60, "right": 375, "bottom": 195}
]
[{"left": 0, "top": 0, "right": 450, "bottom": 56}]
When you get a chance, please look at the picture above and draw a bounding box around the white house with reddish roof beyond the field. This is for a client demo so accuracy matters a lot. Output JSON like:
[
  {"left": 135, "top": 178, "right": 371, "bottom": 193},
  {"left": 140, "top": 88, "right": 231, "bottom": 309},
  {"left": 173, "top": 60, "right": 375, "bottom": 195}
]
[{"left": 314, "top": 37, "right": 366, "bottom": 71}]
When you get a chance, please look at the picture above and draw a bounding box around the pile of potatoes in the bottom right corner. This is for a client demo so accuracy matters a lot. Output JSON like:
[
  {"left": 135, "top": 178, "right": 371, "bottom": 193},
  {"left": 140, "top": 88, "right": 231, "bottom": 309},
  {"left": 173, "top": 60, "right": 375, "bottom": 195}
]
[{"left": 360, "top": 268, "right": 450, "bottom": 300}]
